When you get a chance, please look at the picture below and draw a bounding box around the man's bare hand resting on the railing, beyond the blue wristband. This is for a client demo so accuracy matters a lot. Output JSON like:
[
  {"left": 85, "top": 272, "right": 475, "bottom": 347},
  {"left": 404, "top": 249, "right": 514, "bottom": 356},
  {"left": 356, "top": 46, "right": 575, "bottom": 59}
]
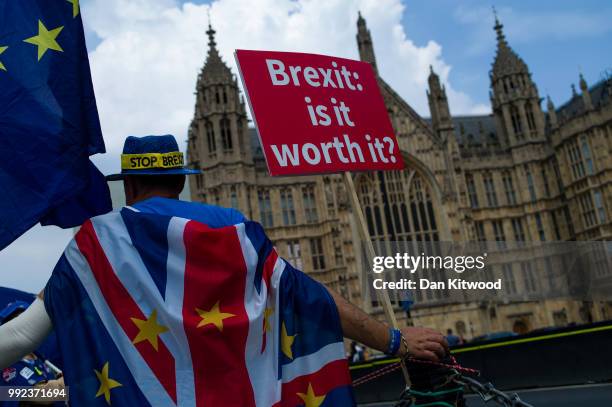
[{"left": 400, "top": 327, "right": 448, "bottom": 362}]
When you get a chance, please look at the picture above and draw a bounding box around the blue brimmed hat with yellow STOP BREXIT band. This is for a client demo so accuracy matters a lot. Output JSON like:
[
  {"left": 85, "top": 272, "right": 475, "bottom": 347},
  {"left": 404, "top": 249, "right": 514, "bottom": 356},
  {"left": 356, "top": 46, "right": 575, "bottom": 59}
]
[{"left": 106, "top": 135, "right": 200, "bottom": 181}]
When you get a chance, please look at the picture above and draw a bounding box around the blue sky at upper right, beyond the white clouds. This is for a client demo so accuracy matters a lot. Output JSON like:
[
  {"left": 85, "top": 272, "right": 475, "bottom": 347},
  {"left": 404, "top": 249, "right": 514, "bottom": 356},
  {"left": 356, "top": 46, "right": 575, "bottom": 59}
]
[{"left": 402, "top": 0, "right": 612, "bottom": 109}]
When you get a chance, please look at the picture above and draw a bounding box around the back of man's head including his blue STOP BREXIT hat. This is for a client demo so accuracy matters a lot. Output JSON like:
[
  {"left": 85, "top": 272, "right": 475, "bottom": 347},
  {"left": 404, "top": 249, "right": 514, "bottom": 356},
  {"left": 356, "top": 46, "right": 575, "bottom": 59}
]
[{"left": 106, "top": 135, "right": 200, "bottom": 205}]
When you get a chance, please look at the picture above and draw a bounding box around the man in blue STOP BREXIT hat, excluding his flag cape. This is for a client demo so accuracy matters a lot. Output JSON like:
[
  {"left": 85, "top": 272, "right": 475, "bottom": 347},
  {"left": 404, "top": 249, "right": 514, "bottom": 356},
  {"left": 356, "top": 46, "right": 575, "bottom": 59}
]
[{"left": 0, "top": 135, "right": 447, "bottom": 386}]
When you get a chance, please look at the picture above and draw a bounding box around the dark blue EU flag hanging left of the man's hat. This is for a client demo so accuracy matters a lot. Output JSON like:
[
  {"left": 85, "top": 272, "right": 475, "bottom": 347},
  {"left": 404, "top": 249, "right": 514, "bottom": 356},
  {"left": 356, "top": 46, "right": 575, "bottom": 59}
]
[{"left": 0, "top": 0, "right": 111, "bottom": 249}]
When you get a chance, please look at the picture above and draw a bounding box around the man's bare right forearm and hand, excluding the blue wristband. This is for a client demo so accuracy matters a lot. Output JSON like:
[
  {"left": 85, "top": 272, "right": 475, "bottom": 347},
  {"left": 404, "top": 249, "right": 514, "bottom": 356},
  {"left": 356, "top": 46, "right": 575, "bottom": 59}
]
[{"left": 327, "top": 289, "right": 448, "bottom": 361}]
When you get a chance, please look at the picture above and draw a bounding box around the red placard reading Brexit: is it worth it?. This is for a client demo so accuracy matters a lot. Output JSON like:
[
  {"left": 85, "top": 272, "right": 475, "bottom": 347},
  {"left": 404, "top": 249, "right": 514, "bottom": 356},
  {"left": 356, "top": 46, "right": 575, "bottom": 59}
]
[{"left": 236, "top": 50, "right": 404, "bottom": 175}]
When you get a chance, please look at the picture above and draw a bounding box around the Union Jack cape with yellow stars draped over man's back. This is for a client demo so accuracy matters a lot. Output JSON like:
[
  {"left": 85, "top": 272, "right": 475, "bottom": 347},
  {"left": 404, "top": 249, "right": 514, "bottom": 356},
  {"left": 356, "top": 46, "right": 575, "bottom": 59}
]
[{"left": 45, "top": 208, "right": 355, "bottom": 407}]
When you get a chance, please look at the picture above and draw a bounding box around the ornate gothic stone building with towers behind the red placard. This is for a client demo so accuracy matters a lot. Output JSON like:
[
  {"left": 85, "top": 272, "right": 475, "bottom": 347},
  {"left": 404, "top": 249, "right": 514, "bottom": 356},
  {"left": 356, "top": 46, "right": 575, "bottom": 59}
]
[{"left": 188, "top": 15, "right": 612, "bottom": 338}]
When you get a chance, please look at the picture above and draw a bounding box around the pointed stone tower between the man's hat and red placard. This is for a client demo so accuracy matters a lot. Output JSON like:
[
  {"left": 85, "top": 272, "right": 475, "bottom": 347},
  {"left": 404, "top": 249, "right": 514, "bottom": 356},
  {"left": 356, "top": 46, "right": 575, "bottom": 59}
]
[{"left": 188, "top": 25, "right": 253, "bottom": 216}]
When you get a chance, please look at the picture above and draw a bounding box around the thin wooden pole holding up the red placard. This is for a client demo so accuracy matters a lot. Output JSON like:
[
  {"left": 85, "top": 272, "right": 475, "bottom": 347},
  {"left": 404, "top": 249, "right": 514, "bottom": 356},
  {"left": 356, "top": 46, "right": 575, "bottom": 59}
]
[{"left": 344, "top": 171, "right": 412, "bottom": 387}]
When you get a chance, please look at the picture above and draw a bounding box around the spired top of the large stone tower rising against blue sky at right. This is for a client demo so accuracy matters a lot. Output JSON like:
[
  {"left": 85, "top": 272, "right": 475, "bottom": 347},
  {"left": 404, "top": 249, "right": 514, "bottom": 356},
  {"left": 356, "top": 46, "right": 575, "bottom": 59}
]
[{"left": 490, "top": 16, "right": 544, "bottom": 148}]
